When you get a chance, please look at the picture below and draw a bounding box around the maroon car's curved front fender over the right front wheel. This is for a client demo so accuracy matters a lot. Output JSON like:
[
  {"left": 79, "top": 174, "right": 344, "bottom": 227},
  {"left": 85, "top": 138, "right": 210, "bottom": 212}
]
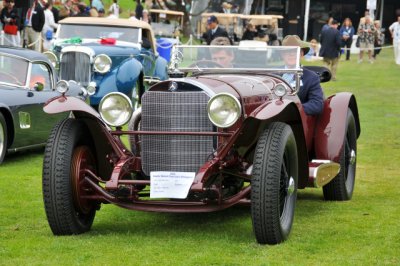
[{"left": 235, "top": 99, "right": 308, "bottom": 188}]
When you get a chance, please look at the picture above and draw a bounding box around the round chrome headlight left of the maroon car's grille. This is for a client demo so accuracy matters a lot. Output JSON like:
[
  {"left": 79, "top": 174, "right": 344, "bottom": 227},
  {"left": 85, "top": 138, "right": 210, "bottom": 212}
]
[{"left": 99, "top": 92, "right": 133, "bottom": 127}]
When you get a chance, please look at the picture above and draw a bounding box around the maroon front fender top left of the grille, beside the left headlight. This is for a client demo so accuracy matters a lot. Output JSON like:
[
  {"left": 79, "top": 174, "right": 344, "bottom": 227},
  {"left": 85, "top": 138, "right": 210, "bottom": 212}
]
[{"left": 43, "top": 95, "right": 100, "bottom": 119}]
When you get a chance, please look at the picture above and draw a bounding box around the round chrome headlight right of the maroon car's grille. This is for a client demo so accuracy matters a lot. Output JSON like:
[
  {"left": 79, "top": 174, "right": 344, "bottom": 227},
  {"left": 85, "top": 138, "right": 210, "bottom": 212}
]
[{"left": 207, "top": 93, "right": 242, "bottom": 128}]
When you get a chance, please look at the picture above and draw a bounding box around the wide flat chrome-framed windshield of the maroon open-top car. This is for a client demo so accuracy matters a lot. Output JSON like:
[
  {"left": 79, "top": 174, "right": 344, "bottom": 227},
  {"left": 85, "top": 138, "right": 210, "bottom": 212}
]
[{"left": 170, "top": 43, "right": 300, "bottom": 72}]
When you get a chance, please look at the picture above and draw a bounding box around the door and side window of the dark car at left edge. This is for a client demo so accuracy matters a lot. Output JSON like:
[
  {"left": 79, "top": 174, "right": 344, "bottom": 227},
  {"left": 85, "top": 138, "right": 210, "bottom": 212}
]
[{"left": 13, "top": 62, "right": 67, "bottom": 148}]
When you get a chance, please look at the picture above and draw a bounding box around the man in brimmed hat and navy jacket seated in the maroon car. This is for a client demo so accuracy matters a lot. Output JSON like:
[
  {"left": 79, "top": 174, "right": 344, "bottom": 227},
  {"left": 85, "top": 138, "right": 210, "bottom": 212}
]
[{"left": 282, "top": 35, "right": 324, "bottom": 115}]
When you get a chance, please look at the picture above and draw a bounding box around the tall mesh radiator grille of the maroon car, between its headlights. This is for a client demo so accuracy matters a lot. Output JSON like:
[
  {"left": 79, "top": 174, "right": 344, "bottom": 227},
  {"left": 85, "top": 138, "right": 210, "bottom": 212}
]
[{"left": 141, "top": 91, "right": 215, "bottom": 175}]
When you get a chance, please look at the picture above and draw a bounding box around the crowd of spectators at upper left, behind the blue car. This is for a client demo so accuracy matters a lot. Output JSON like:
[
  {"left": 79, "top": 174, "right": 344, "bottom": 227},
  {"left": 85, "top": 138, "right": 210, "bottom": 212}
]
[{"left": 0, "top": 0, "right": 155, "bottom": 52}]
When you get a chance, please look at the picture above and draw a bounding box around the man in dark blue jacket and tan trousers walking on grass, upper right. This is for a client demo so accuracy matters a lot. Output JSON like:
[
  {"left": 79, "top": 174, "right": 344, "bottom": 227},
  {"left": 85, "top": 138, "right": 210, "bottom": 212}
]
[{"left": 319, "top": 19, "right": 342, "bottom": 81}]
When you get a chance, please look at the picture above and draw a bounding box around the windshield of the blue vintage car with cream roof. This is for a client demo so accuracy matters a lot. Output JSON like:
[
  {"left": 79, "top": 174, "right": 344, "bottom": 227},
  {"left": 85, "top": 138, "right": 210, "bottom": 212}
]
[{"left": 57, "top": 24, "right": 139, "bottom": 43}]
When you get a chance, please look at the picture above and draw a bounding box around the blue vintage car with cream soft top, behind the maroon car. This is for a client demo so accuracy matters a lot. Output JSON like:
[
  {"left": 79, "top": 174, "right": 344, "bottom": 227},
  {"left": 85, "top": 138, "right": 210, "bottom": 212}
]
[{"left": 46, "top": 17, "right": 167, "bottom": 107}]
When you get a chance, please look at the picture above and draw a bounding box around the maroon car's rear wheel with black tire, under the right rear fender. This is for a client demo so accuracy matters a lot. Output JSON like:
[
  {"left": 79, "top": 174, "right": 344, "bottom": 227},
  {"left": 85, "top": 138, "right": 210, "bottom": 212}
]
[{"left": 323, "top": 109, "right": 357, "bottom": 201}]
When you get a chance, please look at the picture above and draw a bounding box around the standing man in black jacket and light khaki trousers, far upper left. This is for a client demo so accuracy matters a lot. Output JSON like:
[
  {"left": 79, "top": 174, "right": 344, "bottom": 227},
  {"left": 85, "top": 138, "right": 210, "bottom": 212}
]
[{"left": 25, "top": 0, "right": 45, "bottom": 52}]
